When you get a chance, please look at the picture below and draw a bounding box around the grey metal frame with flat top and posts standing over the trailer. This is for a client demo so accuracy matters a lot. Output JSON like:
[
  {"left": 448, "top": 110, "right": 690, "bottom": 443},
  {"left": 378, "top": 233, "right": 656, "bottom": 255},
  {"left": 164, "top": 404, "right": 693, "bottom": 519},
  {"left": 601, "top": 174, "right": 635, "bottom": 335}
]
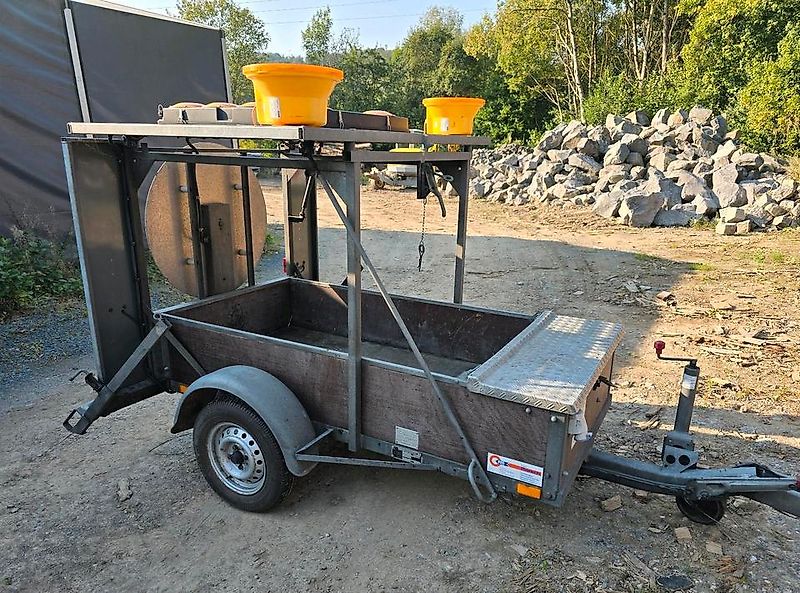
[{"left": 64, "top": 123, "right": 482, "bottom": 468}]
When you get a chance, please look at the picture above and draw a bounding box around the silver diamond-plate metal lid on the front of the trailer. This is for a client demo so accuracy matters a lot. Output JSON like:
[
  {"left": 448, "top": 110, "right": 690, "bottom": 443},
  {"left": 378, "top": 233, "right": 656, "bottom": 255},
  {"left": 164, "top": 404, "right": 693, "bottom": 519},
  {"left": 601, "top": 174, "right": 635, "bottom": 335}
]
[{"left": 467, "top": 311, "right": 622, "bottom": 414}]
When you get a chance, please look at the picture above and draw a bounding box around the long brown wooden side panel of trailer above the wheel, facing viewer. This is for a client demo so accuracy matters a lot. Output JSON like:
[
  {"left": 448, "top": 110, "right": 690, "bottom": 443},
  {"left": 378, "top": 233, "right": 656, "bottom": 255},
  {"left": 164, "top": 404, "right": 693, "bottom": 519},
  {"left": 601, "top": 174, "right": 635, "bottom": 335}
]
[{"left": 166, "top": 324, "right": 549, "bottom": 465}]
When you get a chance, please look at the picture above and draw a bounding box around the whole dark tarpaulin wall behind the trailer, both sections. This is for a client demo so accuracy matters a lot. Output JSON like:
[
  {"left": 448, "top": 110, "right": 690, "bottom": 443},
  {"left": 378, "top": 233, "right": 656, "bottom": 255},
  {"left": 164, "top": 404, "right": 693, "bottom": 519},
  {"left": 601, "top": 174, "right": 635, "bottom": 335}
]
[{"left": 0, "top": 0, "right": 227, "bottom": 235}]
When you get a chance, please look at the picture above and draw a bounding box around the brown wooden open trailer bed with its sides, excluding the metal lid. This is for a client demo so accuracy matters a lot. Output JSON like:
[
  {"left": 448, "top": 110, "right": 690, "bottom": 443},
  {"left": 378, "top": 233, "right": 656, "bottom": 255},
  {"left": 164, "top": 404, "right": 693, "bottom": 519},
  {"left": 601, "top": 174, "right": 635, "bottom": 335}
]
[{"left": 162, "top": 278, "right": 616, "bottom": 504}]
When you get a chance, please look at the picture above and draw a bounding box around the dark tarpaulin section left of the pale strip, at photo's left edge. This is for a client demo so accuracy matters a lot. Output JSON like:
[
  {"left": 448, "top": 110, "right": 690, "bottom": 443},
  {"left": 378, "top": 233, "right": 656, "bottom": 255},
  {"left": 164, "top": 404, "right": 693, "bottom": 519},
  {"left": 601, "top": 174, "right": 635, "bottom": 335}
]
[{"left": 0, "top": 0, "right": 81, "bottom": 235}]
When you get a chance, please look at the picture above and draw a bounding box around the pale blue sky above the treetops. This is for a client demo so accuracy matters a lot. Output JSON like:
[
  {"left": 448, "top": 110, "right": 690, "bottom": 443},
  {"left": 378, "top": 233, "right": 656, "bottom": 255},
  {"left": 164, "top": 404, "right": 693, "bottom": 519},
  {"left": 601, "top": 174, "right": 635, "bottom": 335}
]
[{"left": 120, "top": 0, "right": 497, "bottom": 55}]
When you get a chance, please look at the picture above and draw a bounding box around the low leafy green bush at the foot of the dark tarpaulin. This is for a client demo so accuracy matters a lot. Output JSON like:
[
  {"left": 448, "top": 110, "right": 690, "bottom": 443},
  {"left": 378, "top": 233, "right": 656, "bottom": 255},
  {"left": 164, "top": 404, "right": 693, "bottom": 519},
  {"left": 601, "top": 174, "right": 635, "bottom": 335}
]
[{"left": 0, "top": 230, "right": 82, "bottom": 319}]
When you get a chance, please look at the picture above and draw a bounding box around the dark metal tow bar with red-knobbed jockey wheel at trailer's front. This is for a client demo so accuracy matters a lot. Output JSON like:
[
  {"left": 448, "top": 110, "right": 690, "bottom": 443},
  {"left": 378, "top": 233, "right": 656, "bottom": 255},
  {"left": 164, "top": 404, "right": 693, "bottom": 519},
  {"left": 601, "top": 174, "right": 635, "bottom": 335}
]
[{"left": 581, "top": 341, "right": 800, "bottom": 525}]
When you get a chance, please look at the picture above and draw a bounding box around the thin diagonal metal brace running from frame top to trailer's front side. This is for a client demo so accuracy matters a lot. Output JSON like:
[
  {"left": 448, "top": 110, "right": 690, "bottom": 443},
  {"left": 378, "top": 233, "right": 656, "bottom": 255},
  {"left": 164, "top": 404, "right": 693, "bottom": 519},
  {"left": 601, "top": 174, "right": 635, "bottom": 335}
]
[{"left": 319, "top": 175, "right": 497, "bottom": 500}]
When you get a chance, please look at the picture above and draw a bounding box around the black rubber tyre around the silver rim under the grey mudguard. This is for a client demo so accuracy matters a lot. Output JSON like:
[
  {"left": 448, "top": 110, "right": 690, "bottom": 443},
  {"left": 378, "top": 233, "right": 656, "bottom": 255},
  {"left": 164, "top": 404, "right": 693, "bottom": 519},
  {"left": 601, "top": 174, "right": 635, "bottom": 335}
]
[{"left": 193, "top": 397, "right": 293, "bottom": 513}]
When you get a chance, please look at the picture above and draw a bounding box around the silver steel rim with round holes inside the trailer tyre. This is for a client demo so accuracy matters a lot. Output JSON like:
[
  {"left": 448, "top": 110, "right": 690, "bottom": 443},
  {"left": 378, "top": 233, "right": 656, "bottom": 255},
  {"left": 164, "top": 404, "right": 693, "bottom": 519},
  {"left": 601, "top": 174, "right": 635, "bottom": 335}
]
[{"left": 206, "top": 422, "right": 267, "bottom": 496}]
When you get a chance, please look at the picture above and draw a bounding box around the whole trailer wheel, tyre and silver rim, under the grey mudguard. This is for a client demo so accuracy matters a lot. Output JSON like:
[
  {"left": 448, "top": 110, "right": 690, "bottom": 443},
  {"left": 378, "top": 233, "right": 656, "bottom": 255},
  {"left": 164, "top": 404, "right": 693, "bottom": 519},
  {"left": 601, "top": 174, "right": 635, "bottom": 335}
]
[{"left": 194, "top": 399, "right": 292, "bottom": 513}]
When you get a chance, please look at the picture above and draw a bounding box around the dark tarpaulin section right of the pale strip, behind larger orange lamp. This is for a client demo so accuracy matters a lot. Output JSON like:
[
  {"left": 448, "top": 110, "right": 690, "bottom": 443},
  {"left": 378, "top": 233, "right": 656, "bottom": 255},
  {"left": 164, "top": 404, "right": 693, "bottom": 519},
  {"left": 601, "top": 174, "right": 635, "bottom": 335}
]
[{"left": 71, "top": 2, "right": 227, "bottom": 123}]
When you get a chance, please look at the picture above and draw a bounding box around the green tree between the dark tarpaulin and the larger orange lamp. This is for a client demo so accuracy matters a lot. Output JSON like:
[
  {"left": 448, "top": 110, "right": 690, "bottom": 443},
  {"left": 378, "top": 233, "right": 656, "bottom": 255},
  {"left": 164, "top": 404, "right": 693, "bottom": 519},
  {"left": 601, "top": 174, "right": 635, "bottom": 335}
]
[{"left": 177, "top": 0, "right": 269, "bottom": 104}]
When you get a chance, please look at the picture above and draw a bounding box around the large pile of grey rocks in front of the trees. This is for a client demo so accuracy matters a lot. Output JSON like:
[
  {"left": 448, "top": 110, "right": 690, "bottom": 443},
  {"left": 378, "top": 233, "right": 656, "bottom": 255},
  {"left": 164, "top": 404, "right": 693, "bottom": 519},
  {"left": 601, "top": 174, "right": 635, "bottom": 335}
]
[{"left": 470, "top": 107, "right": 800, "bottom": 235}]
